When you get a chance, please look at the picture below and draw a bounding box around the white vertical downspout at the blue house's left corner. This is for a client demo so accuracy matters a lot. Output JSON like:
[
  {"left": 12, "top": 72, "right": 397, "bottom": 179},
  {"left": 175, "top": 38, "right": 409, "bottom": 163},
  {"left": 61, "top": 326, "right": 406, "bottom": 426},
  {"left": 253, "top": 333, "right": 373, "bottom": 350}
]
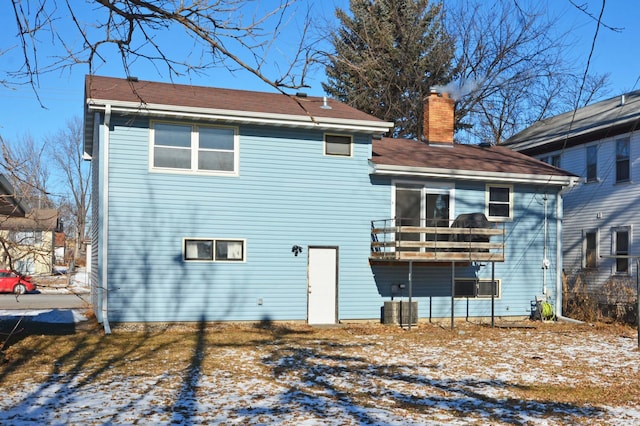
[{"left": 100, "top": 104, "right": 111, "bottom": 334}]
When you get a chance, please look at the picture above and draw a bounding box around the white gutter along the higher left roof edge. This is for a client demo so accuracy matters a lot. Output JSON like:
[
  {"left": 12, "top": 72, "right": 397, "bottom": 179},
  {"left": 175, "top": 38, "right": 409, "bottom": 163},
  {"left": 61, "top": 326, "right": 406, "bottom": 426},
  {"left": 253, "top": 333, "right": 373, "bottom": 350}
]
[{"left": 87, "top": 98, "right": 393, "bottom": 134}]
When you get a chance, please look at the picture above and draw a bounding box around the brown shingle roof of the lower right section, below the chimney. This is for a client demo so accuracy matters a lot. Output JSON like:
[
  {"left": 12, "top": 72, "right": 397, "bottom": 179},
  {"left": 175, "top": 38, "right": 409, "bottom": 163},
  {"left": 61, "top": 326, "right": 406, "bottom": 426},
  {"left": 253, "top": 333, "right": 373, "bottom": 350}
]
[{"left": 371, "top": 138, "right": 573, "bottom": 177}]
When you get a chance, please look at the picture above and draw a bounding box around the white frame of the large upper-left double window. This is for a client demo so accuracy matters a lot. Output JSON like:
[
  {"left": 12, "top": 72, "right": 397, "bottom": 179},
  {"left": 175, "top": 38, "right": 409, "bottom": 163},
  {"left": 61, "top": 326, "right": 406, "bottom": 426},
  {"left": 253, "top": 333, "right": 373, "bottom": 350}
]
[{"left": 149, "top": 120, "right": 240, "bottom": 176}]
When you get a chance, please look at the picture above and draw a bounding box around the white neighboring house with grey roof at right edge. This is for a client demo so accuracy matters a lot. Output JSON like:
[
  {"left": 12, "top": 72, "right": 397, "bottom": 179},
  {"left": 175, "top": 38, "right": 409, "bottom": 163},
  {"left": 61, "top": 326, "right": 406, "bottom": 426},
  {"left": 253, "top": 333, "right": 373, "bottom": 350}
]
[{"left": 504, "top": 91, "right": 640, "bottom": 302}]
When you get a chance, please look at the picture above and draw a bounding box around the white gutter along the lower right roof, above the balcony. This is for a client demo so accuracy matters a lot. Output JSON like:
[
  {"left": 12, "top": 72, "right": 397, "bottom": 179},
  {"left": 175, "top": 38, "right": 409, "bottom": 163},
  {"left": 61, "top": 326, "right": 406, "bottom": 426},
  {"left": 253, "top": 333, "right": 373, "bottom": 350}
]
[{"left": 370, "top": 162, "right": 580, "bottom": 186}]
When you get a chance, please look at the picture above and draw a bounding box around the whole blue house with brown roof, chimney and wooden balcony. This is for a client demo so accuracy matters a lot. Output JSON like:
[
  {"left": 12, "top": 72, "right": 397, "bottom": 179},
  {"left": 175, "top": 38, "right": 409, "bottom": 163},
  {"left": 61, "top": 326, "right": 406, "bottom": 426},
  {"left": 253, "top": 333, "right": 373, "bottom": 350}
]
[{"left": 85, "top": 76, "right": 574, "bottom": 331}]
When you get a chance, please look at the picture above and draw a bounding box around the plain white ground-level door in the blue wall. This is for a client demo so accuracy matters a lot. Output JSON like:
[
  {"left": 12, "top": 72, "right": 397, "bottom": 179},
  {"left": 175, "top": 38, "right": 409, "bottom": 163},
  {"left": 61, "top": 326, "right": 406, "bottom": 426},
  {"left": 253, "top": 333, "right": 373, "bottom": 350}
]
[{"left": 307, "top": 247, "right": 338, "bottom": 324}]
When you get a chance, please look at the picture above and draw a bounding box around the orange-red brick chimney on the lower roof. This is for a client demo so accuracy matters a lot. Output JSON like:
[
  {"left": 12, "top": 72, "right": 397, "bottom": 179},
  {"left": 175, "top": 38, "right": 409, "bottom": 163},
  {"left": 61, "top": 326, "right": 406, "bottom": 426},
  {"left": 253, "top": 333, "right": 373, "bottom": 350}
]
[{"left": 423, "top": 88, "right": 454, "bottom": 144}]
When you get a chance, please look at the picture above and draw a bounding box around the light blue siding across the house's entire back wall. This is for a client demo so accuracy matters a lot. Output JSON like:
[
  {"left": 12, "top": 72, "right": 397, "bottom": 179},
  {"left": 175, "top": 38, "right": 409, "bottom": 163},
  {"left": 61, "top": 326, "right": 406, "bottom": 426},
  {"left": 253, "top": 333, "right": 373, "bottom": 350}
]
[{"left": 94, "top": 117, "right": 557, "bottom": 322}]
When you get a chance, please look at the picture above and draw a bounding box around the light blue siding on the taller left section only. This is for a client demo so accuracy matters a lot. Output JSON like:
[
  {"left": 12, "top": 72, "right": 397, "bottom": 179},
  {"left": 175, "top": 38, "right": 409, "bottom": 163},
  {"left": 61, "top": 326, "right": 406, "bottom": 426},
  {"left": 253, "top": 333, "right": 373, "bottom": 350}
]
[{"left": 103, "top": 115, "right": 388, "bottom": 321}]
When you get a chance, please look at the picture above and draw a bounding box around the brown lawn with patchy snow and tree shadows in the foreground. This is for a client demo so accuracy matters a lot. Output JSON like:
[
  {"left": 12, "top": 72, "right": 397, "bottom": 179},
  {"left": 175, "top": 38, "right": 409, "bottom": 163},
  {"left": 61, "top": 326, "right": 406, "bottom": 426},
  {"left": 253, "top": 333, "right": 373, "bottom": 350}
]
[{"left": 0, "top": 323, "right": 640, "bottom": 425}]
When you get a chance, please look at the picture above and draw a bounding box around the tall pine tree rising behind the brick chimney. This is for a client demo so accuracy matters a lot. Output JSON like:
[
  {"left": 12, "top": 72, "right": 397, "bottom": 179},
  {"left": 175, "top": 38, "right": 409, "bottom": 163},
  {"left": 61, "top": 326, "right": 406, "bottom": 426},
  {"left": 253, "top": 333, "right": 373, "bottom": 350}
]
[{"left": 323, "top": 0, "right": 455, "bottom": 139}]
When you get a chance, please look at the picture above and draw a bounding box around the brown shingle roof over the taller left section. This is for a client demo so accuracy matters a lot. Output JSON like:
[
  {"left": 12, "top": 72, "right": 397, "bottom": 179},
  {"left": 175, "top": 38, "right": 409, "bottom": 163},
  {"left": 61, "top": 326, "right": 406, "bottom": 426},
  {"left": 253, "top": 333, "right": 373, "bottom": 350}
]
[{"left": 85, "top": 75, "right": 383, "bottom": 123}]
